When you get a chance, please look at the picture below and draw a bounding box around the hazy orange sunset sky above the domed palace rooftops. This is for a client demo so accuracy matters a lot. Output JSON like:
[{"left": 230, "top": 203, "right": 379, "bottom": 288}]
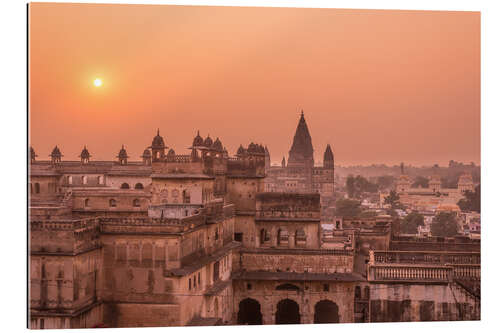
[{"left": 29, "top": 3, "right": 480, "bottom": 165}]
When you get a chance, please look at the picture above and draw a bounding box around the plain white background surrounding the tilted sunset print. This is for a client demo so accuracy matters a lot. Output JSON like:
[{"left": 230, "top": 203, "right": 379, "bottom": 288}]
[{"left": 0, "top": 0, "right": 500, "bottom": 332}]
